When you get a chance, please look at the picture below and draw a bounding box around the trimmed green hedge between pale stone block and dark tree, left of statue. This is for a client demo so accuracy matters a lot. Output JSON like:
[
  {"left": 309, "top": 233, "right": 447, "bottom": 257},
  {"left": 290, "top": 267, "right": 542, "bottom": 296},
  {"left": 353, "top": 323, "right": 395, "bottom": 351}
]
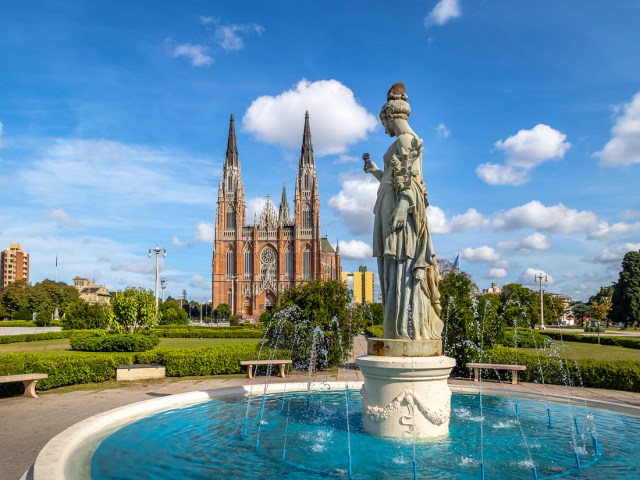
[{"left": 136, "top": 343, "right": 290, "bottom": 377}]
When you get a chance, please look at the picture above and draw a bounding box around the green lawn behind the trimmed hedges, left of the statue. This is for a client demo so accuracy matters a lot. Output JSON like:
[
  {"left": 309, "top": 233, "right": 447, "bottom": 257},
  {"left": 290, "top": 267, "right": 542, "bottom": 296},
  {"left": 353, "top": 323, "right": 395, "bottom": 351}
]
[{"left": 0, "top": 338, "right": 262, "bottom": 353}]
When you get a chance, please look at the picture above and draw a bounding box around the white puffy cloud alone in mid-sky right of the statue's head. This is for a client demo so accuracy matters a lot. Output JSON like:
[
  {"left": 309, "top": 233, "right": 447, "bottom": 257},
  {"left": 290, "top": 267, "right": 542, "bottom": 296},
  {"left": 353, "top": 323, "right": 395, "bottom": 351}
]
[{"left": 476, "top": 124, "right": 571, "bottom": 185}]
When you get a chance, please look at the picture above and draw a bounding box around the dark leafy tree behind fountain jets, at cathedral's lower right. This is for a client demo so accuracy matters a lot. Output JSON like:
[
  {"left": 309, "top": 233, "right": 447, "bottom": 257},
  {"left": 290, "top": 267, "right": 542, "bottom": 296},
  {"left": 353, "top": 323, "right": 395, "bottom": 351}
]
[{"left": 267, "top": 280, "right": 361, "bottom": 369}]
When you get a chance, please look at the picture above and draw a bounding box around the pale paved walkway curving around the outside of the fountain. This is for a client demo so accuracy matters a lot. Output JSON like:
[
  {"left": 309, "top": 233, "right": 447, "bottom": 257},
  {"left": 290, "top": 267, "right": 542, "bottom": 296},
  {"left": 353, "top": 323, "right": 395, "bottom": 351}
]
[{"left": 0, "top": 337, "right": 640, "bottom": 480}]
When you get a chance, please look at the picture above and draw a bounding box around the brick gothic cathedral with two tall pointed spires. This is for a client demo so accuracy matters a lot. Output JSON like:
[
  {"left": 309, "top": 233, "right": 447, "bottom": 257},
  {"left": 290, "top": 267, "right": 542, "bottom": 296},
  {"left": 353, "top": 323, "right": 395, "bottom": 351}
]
[{"left": 211, "top": 113, "right": 342, "bottom": 316}]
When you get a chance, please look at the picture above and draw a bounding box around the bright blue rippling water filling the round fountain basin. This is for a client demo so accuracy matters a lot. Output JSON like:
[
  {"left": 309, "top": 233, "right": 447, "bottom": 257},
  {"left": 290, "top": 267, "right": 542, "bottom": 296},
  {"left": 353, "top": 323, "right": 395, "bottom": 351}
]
[{"left": 36, "top": 384, "right": 640, "bottom": 480}]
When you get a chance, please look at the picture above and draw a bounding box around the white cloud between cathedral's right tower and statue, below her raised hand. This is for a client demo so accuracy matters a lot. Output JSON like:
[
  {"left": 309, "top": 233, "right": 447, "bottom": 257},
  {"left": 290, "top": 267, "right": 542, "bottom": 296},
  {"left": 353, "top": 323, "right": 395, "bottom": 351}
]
[{"left": 329, "top": 175, "right": 380, "bottom": 236}]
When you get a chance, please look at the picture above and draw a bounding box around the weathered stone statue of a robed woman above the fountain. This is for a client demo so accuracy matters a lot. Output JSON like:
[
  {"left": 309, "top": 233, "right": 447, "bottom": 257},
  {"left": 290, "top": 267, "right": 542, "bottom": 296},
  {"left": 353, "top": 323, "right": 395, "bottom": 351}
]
[{"left": 362, "top": 83, "right": 444, "bottom": 340}]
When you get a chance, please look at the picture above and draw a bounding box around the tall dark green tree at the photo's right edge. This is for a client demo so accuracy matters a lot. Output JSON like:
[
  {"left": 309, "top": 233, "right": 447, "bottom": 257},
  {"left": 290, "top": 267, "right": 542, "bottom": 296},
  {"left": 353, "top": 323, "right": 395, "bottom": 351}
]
[{"left": 611, "top": 252, "right": 640, "bottom": 328}]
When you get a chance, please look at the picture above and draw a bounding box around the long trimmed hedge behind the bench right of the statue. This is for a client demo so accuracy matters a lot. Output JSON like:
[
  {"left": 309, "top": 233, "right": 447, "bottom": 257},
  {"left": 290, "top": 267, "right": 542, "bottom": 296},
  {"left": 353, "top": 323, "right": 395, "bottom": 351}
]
[{"left": 483, "top": 346, "right": 640, "bottom": 392}]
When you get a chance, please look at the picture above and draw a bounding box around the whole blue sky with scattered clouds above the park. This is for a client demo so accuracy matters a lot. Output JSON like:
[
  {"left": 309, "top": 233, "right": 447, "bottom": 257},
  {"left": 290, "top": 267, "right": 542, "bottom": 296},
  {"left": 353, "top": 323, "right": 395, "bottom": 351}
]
[{"left": 0, "top": 0, "right": 640, "bottom": 300}]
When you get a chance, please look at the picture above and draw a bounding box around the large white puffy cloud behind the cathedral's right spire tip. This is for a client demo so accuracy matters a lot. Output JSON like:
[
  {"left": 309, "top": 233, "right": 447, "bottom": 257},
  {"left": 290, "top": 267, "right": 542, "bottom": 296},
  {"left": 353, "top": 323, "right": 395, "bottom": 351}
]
[{"left": 242, "top": 80, "right": 377, "bottom": 156}]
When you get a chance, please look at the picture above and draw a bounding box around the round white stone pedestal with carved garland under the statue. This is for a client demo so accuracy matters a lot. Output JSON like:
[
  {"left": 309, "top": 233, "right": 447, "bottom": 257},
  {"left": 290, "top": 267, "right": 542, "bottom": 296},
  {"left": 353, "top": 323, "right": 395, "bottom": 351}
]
[{"left": 356, "top": 339, "right": 456, "bottom": 440}]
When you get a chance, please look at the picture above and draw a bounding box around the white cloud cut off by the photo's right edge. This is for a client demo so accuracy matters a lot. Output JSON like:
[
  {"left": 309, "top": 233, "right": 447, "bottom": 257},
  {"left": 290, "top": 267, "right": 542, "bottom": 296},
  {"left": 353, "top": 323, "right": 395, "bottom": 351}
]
[{"left": 594, "top": 92, "right": 640, "bottom": 167}]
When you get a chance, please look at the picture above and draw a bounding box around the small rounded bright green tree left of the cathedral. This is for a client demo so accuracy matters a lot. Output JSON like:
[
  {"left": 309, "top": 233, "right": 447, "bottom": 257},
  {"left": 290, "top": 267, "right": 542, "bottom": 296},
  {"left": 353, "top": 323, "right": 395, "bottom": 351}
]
[{"left": 111, "top": 288, "right": 156, "bottom": 333}]
